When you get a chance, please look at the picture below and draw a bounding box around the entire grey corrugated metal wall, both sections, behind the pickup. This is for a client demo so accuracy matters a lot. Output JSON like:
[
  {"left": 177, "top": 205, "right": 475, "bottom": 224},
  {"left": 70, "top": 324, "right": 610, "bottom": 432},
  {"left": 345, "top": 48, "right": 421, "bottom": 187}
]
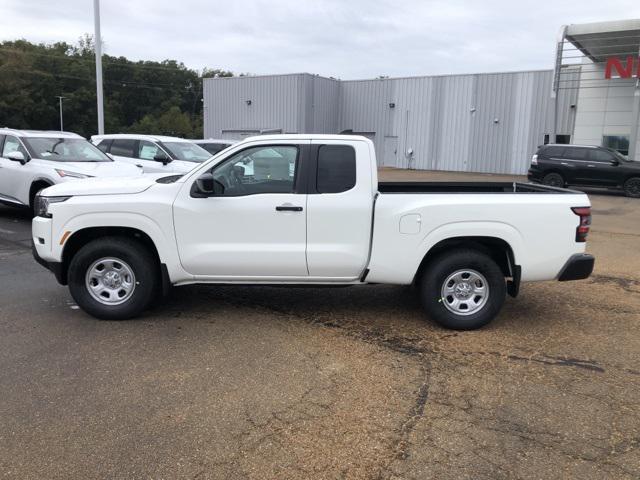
[{"left": 204, "top": 70, "right": 577, "bottom": 174}]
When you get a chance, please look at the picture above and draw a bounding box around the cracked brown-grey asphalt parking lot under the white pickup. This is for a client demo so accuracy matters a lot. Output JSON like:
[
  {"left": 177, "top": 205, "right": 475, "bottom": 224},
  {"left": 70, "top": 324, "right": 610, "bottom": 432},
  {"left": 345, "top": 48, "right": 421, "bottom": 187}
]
[{"left": 0, "top": 171, "right": 640, "bottom": 479}]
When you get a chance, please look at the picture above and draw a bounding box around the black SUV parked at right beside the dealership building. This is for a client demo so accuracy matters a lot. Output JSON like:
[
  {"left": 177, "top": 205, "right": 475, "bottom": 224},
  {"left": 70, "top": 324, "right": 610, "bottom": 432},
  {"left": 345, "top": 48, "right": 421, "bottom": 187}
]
[{"left": 528, "top": 144, "right": 640, "bottom": 198}]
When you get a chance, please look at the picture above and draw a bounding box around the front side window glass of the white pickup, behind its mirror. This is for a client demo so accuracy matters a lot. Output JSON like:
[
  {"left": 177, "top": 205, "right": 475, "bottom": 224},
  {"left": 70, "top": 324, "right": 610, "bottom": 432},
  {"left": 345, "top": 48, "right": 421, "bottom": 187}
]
[{"left": 212, "top": 145, "right": 298, "bottom": 196}]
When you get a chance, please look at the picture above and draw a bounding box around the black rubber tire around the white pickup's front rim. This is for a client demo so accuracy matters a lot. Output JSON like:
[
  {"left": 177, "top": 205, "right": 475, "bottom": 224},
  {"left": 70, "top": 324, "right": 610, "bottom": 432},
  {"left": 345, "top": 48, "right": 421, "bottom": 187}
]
[{"left": 68, "top": 237, "right": 160, "bottom": 320}]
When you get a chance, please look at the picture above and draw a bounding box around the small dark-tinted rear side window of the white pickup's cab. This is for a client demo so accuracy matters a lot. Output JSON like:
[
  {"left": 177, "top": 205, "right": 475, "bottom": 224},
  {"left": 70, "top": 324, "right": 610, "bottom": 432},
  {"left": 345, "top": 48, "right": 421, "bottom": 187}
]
[{"left": 316, "top": 145, "right": 356, "bottom": 193}]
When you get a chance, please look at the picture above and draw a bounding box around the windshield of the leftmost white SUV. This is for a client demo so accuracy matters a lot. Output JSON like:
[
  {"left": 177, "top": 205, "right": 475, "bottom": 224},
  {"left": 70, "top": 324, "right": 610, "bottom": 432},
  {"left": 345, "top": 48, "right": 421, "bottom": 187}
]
[{"left": 23, "top": 137, "right": 113, "bottom": 162}]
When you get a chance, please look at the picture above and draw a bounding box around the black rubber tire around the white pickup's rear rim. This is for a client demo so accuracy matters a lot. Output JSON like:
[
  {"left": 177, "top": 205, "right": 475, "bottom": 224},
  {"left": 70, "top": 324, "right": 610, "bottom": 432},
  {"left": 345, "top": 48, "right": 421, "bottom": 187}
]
[{"left": 420, "top": 249, "right": 507, "bottom": 330}]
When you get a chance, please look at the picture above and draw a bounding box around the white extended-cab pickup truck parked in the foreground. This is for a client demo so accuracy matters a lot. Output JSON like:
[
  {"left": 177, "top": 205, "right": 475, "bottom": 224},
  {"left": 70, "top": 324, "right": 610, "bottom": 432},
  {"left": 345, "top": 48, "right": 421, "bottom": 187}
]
[{"left": 33, "top": 135, "right": 594, "bottom": 329}]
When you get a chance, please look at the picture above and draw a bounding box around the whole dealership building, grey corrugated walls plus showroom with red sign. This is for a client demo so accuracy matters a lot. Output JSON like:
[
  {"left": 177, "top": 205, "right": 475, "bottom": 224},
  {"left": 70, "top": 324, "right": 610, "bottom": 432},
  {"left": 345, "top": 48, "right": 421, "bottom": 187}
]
[{"left": 203, "top": 20, "right": 640, "bottom": 174}]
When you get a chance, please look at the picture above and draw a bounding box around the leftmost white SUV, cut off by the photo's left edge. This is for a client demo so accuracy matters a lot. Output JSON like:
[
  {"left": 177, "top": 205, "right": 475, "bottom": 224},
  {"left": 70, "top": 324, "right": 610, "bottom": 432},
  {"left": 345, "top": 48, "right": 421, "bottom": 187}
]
[{"left": 0, "top": 128, "right": 142, "bottom": 212}]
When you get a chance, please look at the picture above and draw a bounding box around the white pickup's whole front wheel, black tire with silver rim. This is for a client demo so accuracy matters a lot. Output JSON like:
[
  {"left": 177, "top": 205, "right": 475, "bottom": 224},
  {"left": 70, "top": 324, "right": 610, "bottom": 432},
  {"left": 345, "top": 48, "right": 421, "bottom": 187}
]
[{"left": 68, "top": 237, "right": 159, "bottom": 320}]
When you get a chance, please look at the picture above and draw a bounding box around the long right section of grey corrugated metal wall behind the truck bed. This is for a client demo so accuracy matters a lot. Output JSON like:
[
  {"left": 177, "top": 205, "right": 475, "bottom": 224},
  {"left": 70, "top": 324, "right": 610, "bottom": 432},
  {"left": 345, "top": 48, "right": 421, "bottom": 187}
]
[{"left": 340, "top": 70, "right": 577, "bottom": 174}]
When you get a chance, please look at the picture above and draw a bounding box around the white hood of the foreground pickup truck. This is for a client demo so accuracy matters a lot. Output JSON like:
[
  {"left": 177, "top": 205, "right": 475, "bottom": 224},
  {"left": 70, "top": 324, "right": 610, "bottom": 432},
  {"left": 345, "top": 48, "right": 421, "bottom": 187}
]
[{"left": 42, "top": 173, "right": 175, "bottom": 197}]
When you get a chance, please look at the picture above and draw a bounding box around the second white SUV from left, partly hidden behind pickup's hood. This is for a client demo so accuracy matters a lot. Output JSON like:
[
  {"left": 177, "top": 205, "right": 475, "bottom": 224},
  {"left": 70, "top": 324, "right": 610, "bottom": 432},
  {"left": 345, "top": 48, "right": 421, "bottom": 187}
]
[{"left": 91, "top": 134, "right": 211, "bottom": 173}]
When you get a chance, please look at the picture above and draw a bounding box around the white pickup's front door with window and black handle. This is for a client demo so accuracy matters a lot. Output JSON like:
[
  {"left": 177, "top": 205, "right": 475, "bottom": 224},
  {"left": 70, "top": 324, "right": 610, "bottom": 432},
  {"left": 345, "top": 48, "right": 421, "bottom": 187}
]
[{"left": 173, "top": 141, "right": 309, "bottom": 281}]
